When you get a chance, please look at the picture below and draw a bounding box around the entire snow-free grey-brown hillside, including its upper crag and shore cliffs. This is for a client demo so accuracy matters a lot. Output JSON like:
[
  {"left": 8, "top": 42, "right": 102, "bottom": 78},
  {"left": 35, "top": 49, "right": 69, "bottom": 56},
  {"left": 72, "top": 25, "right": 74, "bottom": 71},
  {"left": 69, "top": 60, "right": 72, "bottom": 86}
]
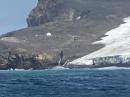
[{"left": 0, "top": 0, "right": 130, "bottom": 69}]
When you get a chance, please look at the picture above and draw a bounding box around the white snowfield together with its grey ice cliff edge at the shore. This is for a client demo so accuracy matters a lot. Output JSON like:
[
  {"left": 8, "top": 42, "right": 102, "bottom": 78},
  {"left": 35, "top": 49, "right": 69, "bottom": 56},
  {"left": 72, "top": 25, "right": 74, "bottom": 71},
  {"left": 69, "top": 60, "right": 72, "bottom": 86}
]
[{"left": 68, "top": 17, "right": 130, "bottom": 66}]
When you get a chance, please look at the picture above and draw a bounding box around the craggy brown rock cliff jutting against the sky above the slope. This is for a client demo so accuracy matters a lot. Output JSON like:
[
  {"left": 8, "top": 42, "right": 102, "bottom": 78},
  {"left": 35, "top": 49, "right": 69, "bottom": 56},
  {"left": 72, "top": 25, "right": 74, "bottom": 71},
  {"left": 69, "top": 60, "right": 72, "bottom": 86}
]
[{"left": 27, "top": 0, "right": 90, "bottom": 27}]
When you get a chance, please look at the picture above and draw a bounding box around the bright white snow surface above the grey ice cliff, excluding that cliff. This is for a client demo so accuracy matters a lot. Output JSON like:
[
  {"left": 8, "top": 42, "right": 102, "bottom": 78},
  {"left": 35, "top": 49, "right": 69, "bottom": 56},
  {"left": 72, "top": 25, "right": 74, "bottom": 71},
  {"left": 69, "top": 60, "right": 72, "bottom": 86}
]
[{"left": 70, "top": 17, "right": 130, "bottom": 65}]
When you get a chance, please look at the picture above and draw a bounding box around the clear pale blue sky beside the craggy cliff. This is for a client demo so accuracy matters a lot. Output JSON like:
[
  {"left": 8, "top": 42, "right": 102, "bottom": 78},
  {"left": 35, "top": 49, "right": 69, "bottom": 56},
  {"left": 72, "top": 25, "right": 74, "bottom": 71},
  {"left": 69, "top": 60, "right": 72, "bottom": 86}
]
[{"left": 0, "top": 0, "right": 37, "bottom": 34}]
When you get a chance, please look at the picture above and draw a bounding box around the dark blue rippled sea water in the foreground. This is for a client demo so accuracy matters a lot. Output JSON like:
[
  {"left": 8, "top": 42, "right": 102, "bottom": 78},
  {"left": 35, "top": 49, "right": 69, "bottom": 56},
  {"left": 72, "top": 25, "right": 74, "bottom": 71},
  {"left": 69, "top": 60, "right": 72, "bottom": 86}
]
[{"left": 0, "top": 69, "right": 130, "bottom": 97}]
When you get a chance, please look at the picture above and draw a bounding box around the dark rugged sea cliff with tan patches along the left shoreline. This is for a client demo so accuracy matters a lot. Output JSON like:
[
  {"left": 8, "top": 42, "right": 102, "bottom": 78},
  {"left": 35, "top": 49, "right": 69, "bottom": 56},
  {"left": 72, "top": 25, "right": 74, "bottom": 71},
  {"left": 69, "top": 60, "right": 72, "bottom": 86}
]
[{"left": 0, "top": 48, "right": 57, "bottom": 70}]
